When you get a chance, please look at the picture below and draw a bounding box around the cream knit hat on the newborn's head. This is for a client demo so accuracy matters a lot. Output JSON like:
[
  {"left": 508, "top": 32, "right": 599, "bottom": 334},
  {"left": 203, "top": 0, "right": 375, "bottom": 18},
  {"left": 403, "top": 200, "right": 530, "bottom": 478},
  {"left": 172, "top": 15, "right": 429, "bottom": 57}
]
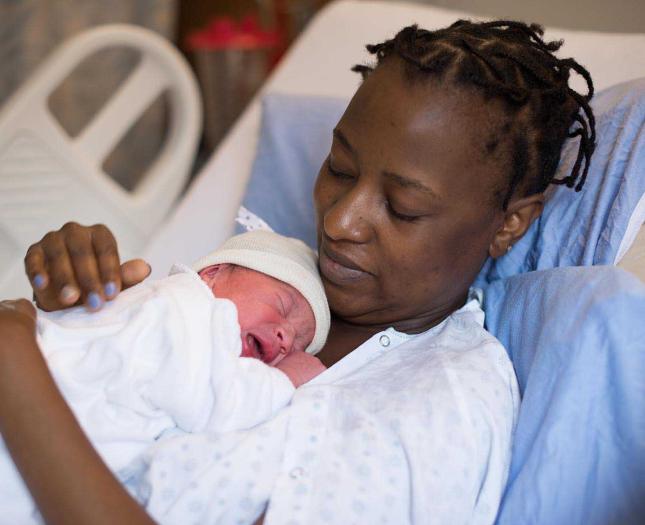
[{"left": 193, "top": 230, "right": 330, "bottom": 354}]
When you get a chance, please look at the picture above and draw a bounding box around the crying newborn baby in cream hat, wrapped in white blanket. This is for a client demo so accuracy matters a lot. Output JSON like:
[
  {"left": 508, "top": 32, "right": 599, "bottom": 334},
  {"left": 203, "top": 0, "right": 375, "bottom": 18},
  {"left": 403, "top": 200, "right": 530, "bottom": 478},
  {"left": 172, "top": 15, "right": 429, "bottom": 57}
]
[{"left": 0, "top": 231, "right": 330, "bottom": 512}]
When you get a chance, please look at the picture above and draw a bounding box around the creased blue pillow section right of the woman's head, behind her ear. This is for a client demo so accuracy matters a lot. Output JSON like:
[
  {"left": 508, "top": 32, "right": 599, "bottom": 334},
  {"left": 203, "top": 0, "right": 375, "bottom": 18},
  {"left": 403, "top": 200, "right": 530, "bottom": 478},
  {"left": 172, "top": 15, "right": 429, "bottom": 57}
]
[{"left": 480, "top": 78, "right": 645, "bottom": 282}]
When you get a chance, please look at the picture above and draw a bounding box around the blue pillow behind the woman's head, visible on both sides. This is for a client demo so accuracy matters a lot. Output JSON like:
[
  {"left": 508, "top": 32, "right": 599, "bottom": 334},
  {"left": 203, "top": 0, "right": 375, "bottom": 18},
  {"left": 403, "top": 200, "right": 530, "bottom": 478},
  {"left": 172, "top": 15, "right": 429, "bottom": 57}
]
[{"left": 238, "top": 78, "right": 645, "bottom": 285}]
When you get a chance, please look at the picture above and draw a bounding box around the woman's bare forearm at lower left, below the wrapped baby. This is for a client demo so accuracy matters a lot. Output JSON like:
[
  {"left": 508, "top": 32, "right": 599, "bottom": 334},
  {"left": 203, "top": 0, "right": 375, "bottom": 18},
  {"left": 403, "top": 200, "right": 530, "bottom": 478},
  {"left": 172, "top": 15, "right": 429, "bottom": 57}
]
[{"left": 0, "top": 300, "right": 153, "bottom": 525}]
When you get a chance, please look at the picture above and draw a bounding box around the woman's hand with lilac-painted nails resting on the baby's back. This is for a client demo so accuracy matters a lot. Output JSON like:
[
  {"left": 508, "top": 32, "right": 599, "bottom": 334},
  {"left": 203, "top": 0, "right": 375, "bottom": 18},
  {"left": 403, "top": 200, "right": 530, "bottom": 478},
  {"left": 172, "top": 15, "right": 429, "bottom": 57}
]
[{"left": 25, "top": 222, "right": 150, "bottom": 311}]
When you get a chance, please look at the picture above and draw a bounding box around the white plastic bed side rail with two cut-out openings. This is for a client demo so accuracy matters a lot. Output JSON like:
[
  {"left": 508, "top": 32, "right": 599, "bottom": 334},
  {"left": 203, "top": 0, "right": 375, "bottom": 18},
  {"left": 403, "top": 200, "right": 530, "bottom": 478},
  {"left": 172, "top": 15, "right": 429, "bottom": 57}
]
[{"left": 0, "top": 25, "right": 201, "bottom": 298}]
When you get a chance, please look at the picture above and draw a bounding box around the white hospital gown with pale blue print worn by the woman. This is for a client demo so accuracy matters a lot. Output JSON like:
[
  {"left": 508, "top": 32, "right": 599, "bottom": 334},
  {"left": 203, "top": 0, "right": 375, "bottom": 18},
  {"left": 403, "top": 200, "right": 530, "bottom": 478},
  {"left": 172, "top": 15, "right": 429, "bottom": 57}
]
[{"left": 127, "top": 292, "right": 519, "bottom": 525}]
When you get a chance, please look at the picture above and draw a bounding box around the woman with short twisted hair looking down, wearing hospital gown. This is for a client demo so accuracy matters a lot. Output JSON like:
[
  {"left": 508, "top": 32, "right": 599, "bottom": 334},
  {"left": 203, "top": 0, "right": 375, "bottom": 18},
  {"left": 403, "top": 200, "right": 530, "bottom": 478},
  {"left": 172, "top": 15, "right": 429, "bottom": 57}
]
[{"left": 0, "top": 21, "right": 594, "bottom": 523}]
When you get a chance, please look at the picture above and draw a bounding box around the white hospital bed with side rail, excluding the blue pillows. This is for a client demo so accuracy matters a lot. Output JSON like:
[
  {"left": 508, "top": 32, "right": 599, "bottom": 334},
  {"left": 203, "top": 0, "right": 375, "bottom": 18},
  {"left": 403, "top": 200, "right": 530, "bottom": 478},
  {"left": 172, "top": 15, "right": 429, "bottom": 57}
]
[{"left": 0, "top": 1, "right": 645, "bottom": 290}]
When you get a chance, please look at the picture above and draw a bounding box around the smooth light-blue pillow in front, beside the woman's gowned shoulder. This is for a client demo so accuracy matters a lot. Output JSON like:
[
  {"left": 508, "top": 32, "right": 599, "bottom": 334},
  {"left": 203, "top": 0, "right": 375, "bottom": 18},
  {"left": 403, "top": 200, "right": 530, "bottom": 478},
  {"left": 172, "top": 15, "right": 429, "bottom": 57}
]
[{"left": 484, "top": 266, "right": 645, "bottom": 525}]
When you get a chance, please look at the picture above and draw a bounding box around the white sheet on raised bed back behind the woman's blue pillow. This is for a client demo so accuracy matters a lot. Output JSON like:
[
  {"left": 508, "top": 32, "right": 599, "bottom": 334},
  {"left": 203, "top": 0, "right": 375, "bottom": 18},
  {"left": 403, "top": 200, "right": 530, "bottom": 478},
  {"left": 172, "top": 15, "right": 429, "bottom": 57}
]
[{"left": 143, "top": 0, "right": 645, "bottom": 282}]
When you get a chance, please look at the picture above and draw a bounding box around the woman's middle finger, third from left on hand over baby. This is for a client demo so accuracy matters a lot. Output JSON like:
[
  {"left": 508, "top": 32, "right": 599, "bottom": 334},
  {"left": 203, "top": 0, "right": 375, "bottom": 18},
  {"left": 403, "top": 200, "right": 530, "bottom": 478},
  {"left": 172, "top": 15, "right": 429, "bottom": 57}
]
[{"left": 62, "top": 223, "right": 105, "bottom": 310}]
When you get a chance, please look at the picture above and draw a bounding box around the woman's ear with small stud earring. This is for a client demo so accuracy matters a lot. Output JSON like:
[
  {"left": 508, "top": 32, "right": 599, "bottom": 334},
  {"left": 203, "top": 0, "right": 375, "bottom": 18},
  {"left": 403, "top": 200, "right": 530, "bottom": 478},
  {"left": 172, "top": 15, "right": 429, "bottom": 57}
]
[{"left": 488, "top": 193, "right": 544, "bottom": 259}]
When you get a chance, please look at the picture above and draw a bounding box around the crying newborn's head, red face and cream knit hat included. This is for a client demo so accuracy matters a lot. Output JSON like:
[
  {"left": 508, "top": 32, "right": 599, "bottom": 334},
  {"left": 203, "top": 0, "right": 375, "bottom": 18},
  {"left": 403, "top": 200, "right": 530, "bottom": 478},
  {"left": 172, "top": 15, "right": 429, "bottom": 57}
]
[{"left": 193, "top": 231, "right": 330, "bottom": 365}]
